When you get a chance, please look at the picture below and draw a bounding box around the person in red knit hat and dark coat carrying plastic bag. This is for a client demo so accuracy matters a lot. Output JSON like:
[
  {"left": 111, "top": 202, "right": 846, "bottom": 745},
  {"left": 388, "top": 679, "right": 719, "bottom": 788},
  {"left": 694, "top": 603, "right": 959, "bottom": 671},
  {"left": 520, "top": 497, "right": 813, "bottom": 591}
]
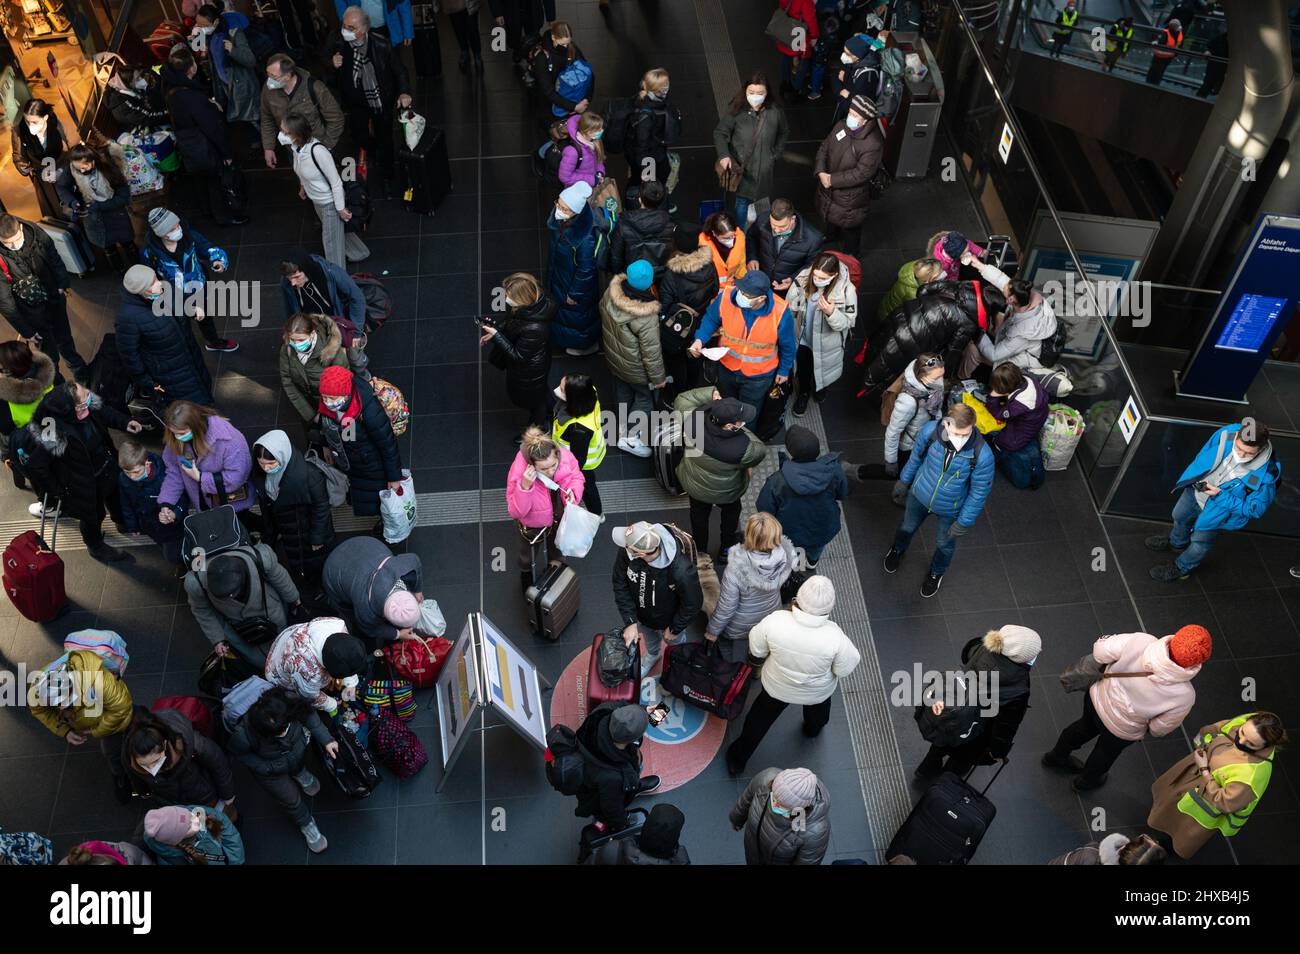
[{"left": 316, "top": 365, "right": 402, "bottom": 530}]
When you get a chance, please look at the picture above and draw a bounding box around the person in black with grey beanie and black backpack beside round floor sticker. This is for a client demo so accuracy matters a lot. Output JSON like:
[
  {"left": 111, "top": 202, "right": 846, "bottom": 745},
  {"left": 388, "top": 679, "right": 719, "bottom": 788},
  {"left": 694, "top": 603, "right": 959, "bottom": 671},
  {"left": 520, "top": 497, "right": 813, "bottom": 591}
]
[{"left": 573, "top": 702, "right": 659, "bottom": 863}]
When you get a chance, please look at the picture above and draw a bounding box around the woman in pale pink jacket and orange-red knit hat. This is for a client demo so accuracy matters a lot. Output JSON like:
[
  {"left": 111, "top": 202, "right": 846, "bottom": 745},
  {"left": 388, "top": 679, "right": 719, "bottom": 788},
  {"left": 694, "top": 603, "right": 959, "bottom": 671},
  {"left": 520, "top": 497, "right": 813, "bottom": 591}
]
[{"left": 1043, "top": 625, "right": 1213, "bottom": 792}]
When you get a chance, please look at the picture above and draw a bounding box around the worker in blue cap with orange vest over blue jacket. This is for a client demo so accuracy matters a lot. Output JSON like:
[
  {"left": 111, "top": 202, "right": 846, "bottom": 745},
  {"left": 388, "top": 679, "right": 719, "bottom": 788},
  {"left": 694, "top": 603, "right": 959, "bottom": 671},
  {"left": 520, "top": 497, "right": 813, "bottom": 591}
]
[{"left": 689, "top": 272, "right": 796, "bottom": 409}]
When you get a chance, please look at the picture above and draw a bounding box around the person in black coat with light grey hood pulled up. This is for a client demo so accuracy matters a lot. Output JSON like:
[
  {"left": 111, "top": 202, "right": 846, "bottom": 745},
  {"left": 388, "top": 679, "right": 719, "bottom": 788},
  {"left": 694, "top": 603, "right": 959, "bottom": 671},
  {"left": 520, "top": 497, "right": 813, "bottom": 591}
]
[{"left": 252, "top": 430, "right": 334, "bottom": 585}]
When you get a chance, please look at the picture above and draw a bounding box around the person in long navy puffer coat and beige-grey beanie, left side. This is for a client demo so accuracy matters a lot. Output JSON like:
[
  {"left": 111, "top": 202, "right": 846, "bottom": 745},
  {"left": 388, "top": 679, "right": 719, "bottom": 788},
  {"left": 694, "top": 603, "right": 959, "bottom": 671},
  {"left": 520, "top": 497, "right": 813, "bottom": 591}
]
[{"left": 113, "top": 265, "right": 212, "bottom": 404}]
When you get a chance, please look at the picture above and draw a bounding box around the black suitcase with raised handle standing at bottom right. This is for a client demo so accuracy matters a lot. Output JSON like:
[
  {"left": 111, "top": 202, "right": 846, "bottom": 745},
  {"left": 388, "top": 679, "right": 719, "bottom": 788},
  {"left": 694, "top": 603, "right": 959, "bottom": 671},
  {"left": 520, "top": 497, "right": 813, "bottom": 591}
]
[{"left": 885, "top": 762, "right": 1006, "bottom": 864}]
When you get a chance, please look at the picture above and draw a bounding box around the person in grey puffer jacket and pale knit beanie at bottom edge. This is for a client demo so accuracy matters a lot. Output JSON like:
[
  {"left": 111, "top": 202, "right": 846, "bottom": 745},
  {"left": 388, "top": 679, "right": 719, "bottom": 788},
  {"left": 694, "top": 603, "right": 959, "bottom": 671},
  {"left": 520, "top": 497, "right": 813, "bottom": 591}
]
[{"left": 731, "top": 768, "right": 831, "bottom": 864}]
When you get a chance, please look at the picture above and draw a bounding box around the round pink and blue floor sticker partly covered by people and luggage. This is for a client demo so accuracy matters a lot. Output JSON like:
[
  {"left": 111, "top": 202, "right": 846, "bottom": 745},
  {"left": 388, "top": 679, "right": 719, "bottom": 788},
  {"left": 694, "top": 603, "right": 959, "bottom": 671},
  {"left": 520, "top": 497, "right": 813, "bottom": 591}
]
[{"left": 550, "top": 646, "right": 727, "bottom": 792}]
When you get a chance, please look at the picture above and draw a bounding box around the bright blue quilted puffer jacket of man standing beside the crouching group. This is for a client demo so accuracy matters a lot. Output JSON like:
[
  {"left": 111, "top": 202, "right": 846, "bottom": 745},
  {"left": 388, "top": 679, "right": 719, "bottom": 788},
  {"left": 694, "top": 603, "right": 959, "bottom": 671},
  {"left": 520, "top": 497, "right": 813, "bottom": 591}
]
[{"left": 900, "top": 421, "right": 993, "bottom": 526}]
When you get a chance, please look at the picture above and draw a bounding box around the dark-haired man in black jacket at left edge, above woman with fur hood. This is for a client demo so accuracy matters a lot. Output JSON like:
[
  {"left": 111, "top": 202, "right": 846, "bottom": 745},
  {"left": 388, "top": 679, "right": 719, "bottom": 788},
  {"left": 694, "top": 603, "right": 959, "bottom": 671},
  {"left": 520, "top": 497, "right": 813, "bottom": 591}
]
[{"left": 0, "top": 214, "right": 86, "bottom": 383}]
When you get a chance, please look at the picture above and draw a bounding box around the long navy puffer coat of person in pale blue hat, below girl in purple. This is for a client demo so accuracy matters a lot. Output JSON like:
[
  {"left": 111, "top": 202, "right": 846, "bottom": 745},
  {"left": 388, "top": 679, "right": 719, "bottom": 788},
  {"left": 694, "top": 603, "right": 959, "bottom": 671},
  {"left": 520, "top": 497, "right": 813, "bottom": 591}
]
[{"left": 546, "top": 205, "right": 608, "bottom": 348}]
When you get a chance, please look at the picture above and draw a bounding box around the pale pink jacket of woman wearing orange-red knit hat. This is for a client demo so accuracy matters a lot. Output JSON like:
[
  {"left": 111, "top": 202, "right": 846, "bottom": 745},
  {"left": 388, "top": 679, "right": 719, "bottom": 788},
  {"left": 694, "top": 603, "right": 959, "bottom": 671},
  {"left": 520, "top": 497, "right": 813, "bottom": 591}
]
[{"left": 1088, "top": 633, "right": 1201, "bottom": 742}]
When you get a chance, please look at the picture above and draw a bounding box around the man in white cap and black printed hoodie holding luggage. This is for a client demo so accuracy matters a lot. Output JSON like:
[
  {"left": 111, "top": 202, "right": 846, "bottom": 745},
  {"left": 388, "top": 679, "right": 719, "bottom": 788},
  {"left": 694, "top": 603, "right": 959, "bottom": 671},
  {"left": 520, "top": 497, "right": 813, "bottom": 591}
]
[{"left": 612, "top": 520, "right": 705, "bottom": 676}]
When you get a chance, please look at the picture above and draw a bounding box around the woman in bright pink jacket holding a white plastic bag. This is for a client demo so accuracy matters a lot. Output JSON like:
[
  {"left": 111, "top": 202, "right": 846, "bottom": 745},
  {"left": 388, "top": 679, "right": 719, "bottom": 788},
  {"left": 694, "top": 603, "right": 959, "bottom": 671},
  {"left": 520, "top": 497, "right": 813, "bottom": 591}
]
[{"left": 506, "top": 428, "right": 586, "bottom": 590}]
